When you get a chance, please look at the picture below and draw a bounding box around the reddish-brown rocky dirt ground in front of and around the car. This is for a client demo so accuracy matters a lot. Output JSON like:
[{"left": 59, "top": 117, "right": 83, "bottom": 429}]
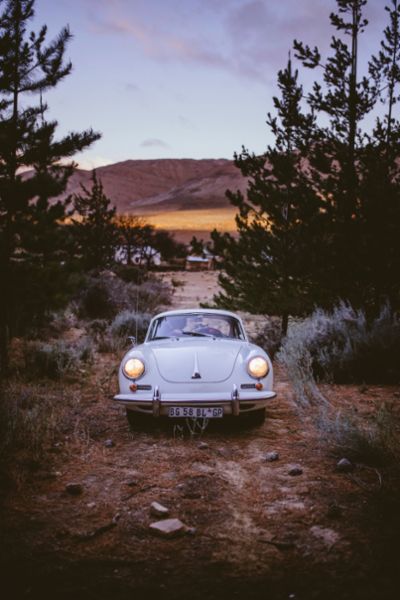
[{"left": 0, "top": 273, "right": 400, "bottom": 600}]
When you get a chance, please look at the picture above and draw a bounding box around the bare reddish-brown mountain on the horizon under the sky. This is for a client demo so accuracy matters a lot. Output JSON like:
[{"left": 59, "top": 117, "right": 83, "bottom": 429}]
[{"left": 62, "top": 159, "right": 247, "bottom": 215}]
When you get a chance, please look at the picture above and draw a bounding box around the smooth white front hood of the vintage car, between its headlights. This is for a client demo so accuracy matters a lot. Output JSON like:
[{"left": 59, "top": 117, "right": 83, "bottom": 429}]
[{"left": 149, "top": 338, "right": 243, "bottom": 383}]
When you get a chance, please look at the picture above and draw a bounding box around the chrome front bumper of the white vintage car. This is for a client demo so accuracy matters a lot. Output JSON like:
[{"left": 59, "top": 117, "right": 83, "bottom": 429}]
[{"left": 114, "top": 385, "right": 276, "bottom": 417}]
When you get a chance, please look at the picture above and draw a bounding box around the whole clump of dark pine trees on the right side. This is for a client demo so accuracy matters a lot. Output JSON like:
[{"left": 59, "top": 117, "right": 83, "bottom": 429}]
[{"left": 212, "top": 0, "right": 400, "bottom": 332}]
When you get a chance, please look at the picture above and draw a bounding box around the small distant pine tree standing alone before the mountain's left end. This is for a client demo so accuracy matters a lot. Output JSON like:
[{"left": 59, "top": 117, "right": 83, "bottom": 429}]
[{"left": 73, "top": 171, "right": 118, "bottom": 269}]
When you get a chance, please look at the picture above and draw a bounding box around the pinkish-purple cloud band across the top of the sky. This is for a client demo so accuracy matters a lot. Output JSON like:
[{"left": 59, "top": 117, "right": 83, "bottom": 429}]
[{"left": 87, "top": 0, "right": 388, "bottom": 83}]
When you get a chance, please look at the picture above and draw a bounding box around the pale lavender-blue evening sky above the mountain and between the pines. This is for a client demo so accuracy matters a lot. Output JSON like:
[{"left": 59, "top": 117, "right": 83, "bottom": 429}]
[{"left": 32, "top": 0, "right": 389, "bottom": 169}]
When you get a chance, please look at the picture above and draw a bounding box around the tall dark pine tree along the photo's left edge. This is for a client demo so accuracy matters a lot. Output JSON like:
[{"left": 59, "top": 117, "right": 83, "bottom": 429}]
[{"left": 0, "top": 0, "right": 99, "bottom": 371}]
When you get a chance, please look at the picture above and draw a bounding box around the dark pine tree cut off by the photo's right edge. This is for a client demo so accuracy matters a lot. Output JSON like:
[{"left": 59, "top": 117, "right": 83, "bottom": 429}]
[{"left": 360, "top": 0, "right": 400, "bottom": 307}]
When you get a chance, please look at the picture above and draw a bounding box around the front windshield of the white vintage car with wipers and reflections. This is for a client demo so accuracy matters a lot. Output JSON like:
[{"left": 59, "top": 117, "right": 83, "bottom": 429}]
[{"left": 148, "top": 313, "right": 245, "bottom": 341}]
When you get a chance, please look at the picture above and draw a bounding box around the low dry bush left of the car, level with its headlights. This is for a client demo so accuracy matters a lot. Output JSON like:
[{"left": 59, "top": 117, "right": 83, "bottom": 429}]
[{"left": 25, "top": 339, "right": 93, "bottom": 379}]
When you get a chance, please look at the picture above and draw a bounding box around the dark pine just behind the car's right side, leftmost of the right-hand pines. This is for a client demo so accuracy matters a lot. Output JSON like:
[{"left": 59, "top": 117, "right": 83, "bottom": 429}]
[{"left": 212, "top": 59, "right": 321, "bottom": 333}]
